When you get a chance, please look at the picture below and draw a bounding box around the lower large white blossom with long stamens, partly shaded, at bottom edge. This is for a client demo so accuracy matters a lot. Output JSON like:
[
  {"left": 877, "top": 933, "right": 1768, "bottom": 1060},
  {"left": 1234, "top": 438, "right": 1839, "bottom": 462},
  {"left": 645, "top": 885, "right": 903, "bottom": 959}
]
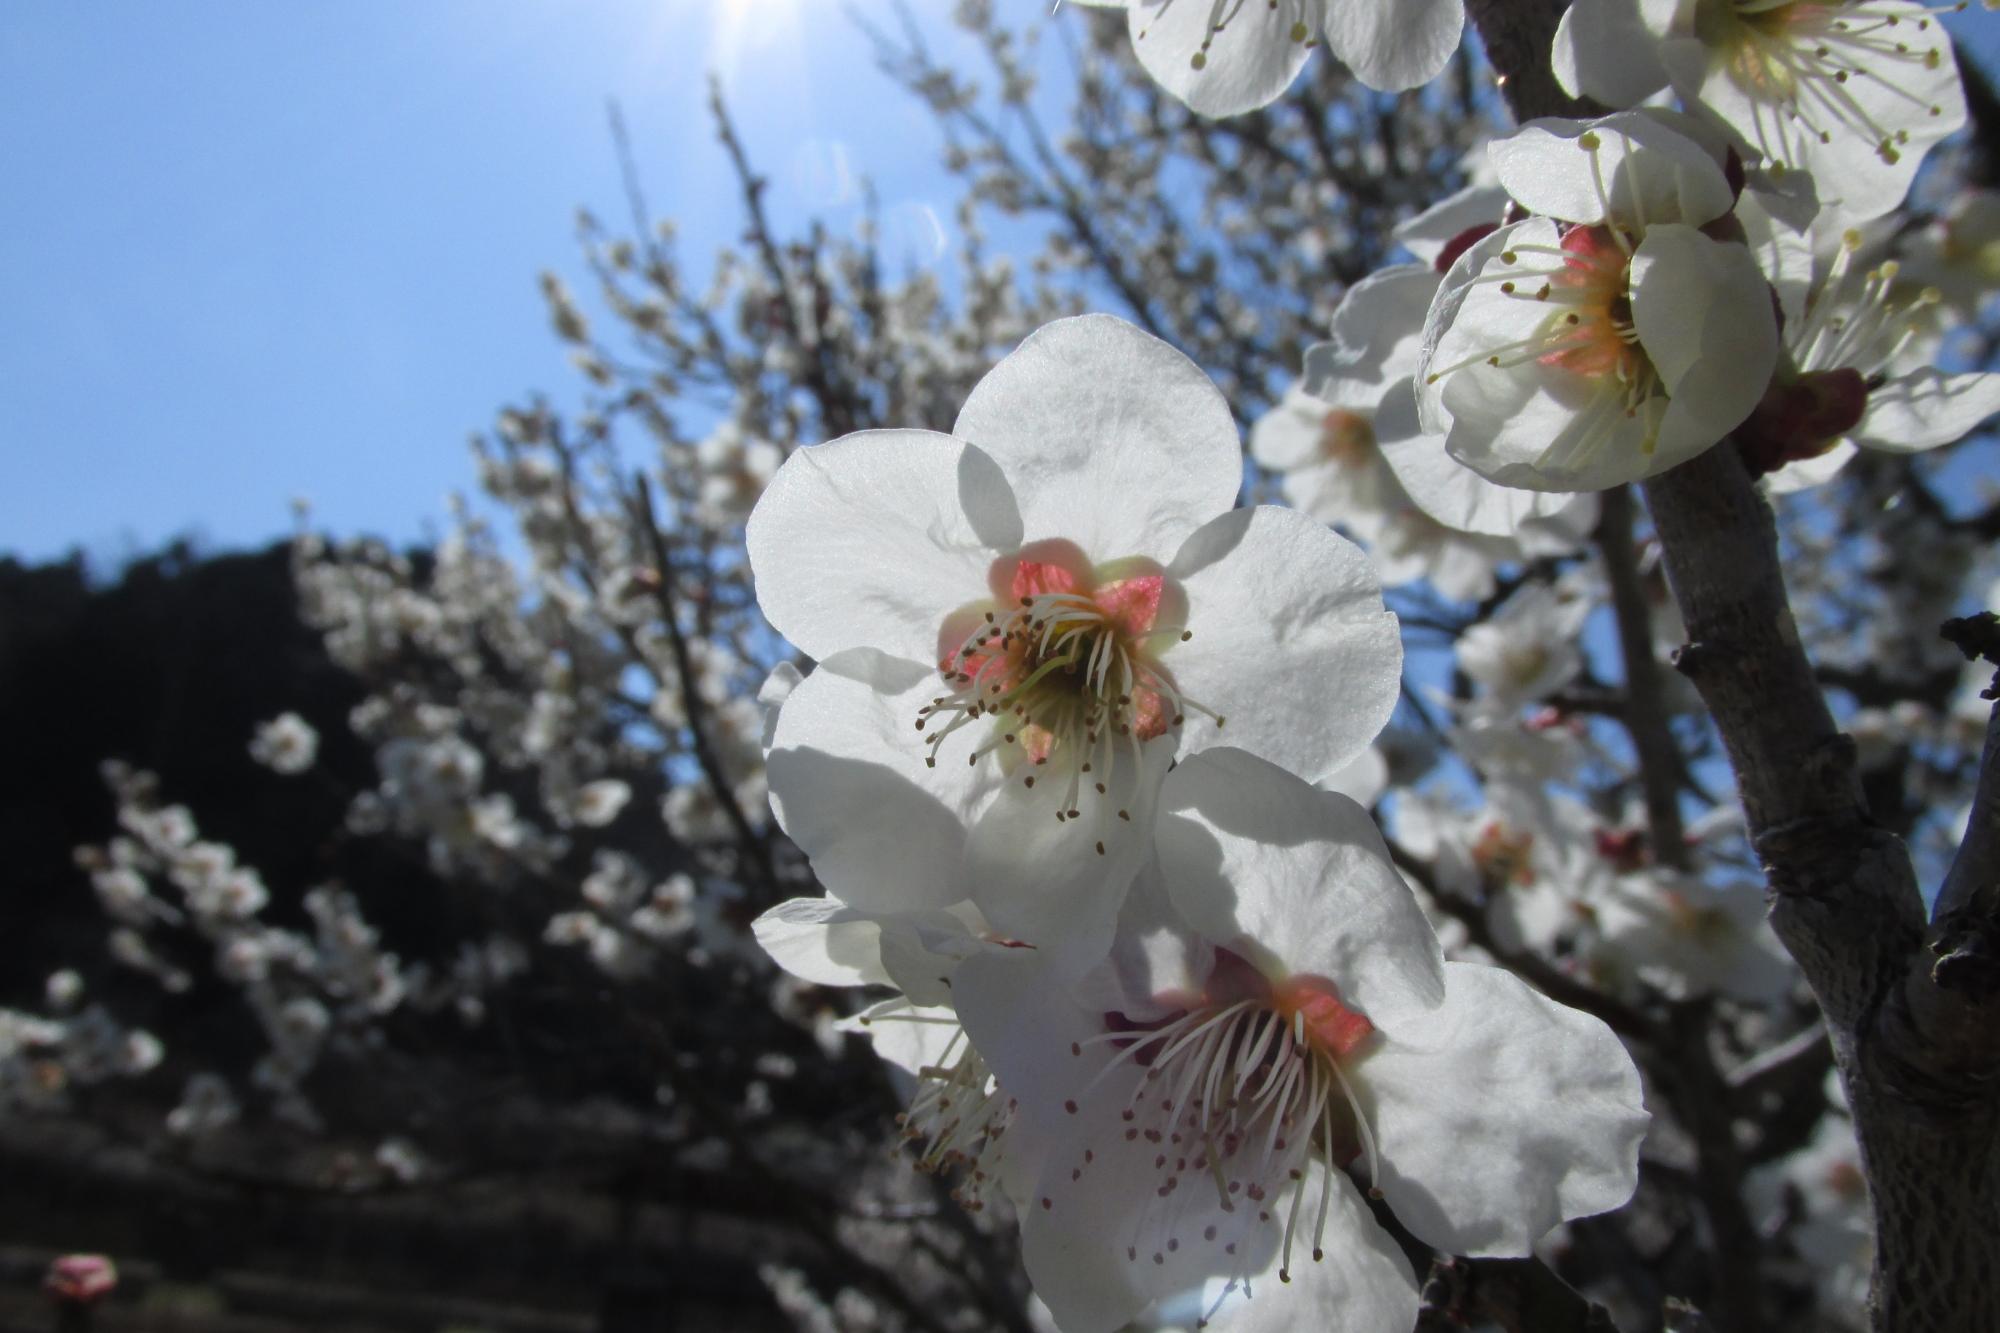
[{"left": 952, "top": 751, "right": 1648, "bottom": 1333}]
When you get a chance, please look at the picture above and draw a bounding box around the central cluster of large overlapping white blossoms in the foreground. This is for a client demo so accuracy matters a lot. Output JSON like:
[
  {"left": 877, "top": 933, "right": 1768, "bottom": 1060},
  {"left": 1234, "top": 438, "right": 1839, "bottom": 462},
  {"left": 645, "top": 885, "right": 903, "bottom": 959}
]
[{"left": 748, "top": 316, "right": 1648, "bottom": 1331}]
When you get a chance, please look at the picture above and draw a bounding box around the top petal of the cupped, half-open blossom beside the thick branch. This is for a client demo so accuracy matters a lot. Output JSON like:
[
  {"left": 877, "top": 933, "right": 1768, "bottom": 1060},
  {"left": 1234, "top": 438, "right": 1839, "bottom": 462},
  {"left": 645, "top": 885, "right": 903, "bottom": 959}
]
[{"left": 1488, "top": 110, "right": 1736, "bottom": 226}]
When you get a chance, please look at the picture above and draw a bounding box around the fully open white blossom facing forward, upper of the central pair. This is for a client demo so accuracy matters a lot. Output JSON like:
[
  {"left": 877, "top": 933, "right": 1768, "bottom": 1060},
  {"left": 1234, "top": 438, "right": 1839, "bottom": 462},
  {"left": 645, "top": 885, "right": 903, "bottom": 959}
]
[{"left": 748, "top": 316, "right": 1402, "bottom": 963}]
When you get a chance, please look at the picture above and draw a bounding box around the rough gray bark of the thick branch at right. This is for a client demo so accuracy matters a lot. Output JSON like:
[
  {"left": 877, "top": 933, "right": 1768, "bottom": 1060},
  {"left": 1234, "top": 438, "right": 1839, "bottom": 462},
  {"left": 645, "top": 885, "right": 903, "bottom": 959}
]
[{"left": 1468, "top": 0, "right": 2000, "bottom": 1333}]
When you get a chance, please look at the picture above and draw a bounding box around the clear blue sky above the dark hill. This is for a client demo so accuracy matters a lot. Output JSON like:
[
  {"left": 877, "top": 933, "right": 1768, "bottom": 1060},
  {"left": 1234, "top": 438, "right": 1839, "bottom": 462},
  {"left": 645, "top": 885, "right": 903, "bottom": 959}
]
[{"left": 0, "top": 0, "right": 1994, "bottom": 566}]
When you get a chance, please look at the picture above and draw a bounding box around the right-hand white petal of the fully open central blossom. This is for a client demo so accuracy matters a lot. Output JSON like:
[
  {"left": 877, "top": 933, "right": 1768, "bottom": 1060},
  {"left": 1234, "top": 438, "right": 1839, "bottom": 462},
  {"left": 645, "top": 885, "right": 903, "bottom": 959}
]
[{"left": 1162, "top": 504, "right": 1402, "bottom": 779}]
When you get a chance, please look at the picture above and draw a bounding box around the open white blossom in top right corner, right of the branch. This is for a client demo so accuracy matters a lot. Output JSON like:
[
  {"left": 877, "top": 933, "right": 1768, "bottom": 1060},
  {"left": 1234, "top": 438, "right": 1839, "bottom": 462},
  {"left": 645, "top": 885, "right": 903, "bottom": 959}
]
[{"left": 1552, "top": 0, "right": 1966, "bottom": 220}]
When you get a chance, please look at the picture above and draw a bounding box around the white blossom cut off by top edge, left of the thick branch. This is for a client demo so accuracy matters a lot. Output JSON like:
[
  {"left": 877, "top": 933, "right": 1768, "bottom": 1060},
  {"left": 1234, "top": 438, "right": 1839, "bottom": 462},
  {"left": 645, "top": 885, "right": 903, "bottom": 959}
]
[{"left": 1078, "top": 0, "right": 1466, "bottom": 116}]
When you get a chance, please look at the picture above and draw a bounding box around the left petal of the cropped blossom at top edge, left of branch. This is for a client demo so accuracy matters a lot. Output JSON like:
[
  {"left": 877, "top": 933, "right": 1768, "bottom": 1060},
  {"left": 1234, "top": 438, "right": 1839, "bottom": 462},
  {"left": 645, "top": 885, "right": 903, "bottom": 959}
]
[{"left": 1128, "top": 0, "right": 1312, "bottom": 116}]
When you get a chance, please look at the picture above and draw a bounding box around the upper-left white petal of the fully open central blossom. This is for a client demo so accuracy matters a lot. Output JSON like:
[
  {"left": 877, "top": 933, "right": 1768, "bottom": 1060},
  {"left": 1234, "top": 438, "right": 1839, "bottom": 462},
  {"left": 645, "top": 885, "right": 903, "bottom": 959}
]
[{"left": 746, "top": 430, "right": 1020, "bottom": 662}]
